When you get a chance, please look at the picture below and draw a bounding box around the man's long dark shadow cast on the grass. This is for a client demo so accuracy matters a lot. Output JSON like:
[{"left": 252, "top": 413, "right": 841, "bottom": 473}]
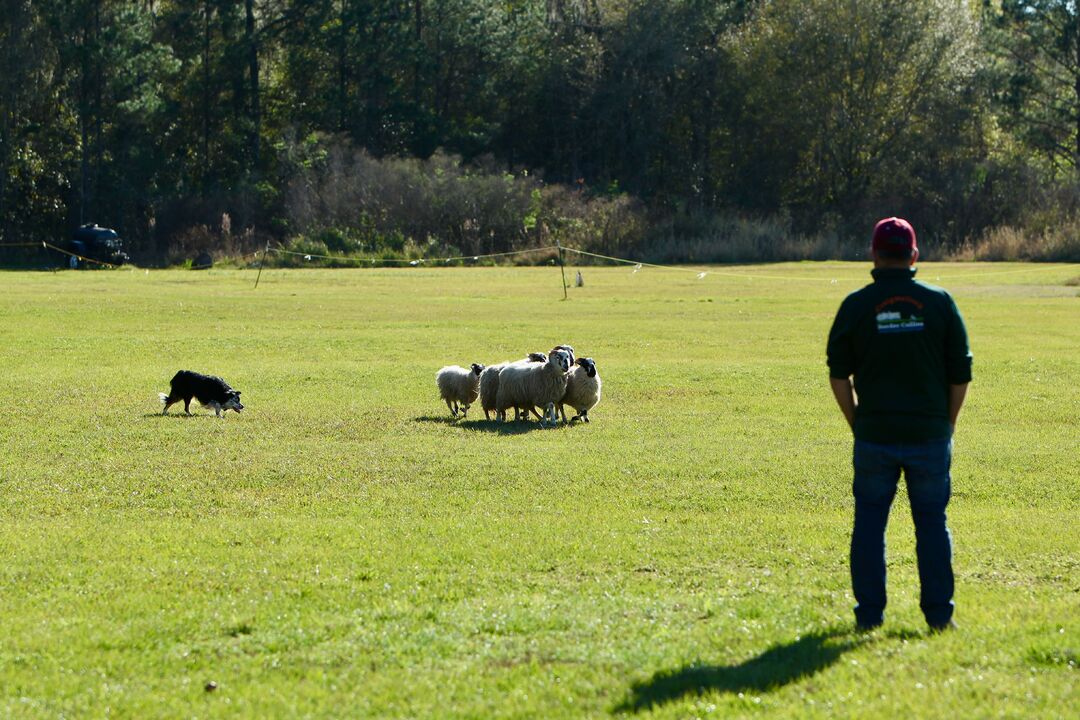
[{"left": 616, "top": 629, "right": 866, "bottom": 712}]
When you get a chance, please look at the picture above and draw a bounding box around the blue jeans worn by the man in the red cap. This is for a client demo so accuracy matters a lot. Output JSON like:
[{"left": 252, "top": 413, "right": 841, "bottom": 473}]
[{"left": 851, "top": 439, "right": 953, "bottom": 626}]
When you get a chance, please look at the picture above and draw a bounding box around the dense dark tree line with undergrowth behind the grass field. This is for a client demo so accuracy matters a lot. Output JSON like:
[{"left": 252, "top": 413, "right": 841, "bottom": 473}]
[{"left": 0, "top": 0, "right": 1080, "bottom": 262}]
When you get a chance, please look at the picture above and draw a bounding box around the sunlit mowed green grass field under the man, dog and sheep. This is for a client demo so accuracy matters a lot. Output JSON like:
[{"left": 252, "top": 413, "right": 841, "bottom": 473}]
[{"left": 0, "top": 263, "right": 1080, "bottom": 718}]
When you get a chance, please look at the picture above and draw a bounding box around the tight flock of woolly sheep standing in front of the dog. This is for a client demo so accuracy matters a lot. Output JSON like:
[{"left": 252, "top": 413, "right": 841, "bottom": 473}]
[{"left": 435, "top": 345, "right": 600, "bottom": 425}]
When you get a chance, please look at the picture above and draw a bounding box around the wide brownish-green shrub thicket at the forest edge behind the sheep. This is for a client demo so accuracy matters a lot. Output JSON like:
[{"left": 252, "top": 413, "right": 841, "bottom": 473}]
[{"left": 285, "top": 133, "right": 646, "bottom": 262}]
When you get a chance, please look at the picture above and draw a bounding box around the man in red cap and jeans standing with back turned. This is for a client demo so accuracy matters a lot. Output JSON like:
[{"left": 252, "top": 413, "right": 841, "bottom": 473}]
[{"left": 827, "top": 217, "right": 971, "bottom": 630}]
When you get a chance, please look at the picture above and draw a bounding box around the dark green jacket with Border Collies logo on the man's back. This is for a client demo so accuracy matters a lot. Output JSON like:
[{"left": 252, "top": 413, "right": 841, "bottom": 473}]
[{"left": 827, "top": 268, "right": 971, "bottom": 443}]
